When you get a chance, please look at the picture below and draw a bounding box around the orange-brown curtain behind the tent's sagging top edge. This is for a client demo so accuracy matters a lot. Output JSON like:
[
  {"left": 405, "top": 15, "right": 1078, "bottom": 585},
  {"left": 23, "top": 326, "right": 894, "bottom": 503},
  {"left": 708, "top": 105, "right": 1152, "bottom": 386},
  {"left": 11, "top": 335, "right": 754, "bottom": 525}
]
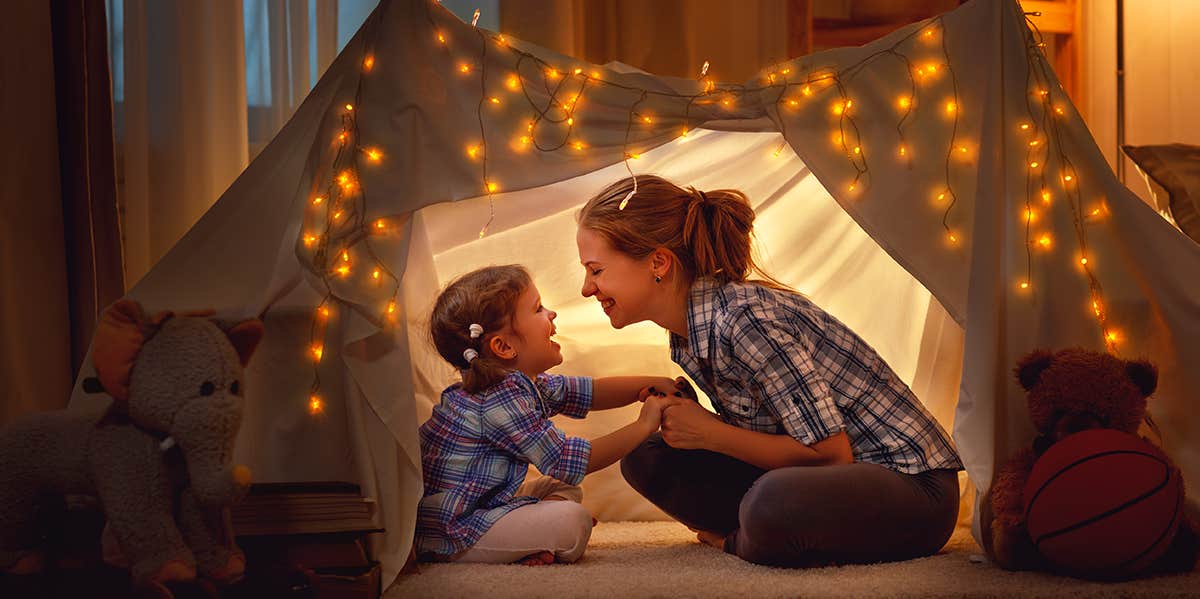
[{"left": 500, "top": 0, "right": 788, "bottom": 82}]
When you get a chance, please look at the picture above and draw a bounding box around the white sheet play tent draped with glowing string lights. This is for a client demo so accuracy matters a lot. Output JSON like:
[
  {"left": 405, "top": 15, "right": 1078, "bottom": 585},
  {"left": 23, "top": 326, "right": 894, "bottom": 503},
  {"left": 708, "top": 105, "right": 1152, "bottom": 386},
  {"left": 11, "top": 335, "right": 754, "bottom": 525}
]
[{"left": 72, "top": 0, "right": 1200, "bottom": 582}]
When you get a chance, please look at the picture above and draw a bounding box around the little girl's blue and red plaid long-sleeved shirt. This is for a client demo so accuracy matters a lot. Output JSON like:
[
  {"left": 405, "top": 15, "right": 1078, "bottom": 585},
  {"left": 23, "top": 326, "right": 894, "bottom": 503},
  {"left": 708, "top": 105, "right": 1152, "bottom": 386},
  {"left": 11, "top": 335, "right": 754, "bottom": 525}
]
[{"left": 416, "top": 372, "right": 592, "bottom": 556}]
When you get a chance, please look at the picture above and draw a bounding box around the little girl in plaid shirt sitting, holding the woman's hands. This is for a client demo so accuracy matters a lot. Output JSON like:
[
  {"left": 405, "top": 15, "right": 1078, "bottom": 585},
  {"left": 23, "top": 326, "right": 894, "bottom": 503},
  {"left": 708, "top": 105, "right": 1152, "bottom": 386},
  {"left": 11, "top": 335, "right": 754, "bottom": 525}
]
[{"left": 416, "top": 265, "right": 682, "bottom": 565}]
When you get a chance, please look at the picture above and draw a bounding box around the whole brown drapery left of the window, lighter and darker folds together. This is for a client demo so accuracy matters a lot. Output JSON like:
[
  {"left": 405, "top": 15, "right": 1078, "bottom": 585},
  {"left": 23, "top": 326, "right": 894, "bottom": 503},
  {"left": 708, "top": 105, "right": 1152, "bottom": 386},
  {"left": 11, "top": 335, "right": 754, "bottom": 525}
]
[{"left": 0, "top": 0, "right": 125, "bottom": 425}]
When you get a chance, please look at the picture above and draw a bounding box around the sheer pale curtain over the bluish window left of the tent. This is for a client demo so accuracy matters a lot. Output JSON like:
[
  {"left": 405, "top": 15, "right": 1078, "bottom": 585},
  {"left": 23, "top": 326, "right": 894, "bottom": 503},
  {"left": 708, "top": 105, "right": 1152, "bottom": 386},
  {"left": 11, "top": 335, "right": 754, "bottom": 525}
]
[{"left": 108, "top": 0, "right": 377, "bottom": 288}]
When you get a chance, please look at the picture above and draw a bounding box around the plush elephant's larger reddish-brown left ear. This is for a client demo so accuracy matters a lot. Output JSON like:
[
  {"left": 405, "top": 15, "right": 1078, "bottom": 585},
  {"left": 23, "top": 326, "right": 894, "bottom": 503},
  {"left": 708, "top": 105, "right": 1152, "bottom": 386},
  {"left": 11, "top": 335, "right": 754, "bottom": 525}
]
[{"left": 91, "top": 299, "right": 145, "bottom": 400}]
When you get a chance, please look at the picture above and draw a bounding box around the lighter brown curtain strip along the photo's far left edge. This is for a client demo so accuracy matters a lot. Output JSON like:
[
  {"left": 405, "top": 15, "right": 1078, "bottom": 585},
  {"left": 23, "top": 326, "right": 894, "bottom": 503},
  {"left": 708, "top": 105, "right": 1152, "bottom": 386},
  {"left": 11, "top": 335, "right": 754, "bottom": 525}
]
[{"left": 0, "top": 0, "right": 72, "bottom": 423}]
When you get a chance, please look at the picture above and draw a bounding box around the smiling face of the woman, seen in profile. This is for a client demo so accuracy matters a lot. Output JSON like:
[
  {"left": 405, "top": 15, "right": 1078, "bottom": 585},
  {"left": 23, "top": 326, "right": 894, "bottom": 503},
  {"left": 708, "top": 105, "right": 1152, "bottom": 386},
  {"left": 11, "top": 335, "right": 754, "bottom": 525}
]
[{"left": 575, "top": 227, "right": 659, "bottom": 329}]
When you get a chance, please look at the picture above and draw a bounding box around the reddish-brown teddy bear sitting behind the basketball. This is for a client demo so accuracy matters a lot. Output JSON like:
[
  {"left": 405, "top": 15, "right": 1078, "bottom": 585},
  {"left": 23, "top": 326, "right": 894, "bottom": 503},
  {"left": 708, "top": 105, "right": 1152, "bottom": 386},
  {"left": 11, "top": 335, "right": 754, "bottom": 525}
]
[{"left": 989, "top": 348, "right": 1198, "bottom": 574}]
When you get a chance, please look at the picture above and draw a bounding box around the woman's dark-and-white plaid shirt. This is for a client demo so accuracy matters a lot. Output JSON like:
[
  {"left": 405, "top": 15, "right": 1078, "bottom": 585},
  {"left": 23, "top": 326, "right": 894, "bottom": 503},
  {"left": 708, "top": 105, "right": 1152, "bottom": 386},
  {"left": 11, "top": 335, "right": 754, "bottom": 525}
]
[{"left": 671, "top": 278, "right": 962, "bottom": 474}]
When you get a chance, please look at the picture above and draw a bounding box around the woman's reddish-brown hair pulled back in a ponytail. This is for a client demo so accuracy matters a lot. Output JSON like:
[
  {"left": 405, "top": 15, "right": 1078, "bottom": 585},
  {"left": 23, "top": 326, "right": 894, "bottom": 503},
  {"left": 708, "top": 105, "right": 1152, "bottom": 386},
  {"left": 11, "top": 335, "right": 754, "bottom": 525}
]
[{"left": 578, "top": 175, "right": 792, "bottom": 290}]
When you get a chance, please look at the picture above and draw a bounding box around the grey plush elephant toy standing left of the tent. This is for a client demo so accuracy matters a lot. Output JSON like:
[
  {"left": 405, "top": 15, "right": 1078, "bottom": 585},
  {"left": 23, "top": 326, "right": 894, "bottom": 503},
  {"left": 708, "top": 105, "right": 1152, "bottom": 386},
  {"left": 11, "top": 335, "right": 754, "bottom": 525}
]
[{"left": 0, "top": 300, "right": 263, "bottom": 595}]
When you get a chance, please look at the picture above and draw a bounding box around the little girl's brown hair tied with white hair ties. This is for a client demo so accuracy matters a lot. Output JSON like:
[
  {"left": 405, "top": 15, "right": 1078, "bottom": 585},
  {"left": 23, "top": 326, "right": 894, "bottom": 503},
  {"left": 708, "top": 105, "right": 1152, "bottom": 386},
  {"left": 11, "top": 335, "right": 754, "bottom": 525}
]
[{"left": 430, "top": 264, "right": 533, "bottom": 394}]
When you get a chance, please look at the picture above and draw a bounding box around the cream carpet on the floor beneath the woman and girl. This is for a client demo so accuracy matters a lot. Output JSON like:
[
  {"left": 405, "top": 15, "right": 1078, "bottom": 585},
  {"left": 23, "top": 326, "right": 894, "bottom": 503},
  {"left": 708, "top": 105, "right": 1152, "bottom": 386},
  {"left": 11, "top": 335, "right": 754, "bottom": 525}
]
[{"left": 384, "top": 522, "right": 1200, "bottom": 599}]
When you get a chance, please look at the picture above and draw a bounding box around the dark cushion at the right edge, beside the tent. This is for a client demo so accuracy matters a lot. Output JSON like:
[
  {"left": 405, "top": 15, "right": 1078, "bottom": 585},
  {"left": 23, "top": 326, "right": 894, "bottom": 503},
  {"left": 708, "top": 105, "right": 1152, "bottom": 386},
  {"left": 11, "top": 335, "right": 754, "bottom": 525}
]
[{"left": 1122, "top": 144, "right": 1200, "bottom": 242}]
